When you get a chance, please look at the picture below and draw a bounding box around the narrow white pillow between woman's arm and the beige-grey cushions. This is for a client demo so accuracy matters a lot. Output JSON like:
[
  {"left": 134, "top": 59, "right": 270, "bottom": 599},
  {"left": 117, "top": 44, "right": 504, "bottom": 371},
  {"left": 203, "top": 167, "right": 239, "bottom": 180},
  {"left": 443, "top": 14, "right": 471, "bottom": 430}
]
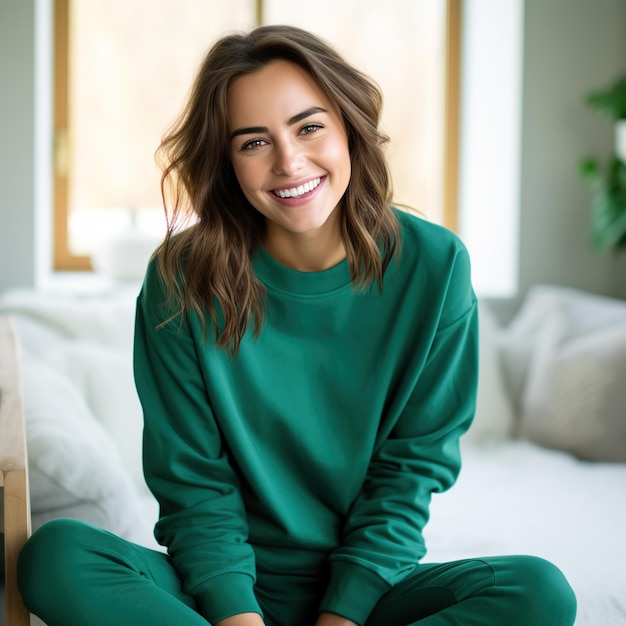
[{"left": 463, "top": 302, "right": 514, "bottom": 444}]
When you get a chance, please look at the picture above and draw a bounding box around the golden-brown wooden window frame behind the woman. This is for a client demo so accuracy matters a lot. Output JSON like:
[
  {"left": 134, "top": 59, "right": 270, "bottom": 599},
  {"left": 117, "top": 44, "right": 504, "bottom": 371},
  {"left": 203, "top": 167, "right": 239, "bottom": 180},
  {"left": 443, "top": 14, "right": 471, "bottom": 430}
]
[{"left": 52, "top": 0, "right": 463, "bottom": 272}]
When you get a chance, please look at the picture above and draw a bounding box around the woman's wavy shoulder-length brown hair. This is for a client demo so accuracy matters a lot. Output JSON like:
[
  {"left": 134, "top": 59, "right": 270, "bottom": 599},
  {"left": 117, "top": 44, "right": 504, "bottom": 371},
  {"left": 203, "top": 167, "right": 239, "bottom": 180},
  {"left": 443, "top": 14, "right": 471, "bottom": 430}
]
[{"left": 156, "top": 26, "right": 399, "bottom": 354}]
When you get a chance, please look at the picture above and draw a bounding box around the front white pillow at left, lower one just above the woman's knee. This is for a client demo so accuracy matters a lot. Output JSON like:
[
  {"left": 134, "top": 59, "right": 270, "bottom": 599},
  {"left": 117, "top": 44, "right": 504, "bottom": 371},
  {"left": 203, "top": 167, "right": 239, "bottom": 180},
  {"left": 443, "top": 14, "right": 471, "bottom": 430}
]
[{"left": 22, "top": 351, "right": 146, "bottom": 538}]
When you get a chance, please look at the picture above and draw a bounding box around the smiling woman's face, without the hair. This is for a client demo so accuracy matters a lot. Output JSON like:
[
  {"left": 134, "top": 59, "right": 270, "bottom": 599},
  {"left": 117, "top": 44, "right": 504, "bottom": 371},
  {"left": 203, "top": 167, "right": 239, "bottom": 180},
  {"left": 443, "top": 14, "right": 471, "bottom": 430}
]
[{"left": 228, "top": 60, "right": 350, "bottom": 260}]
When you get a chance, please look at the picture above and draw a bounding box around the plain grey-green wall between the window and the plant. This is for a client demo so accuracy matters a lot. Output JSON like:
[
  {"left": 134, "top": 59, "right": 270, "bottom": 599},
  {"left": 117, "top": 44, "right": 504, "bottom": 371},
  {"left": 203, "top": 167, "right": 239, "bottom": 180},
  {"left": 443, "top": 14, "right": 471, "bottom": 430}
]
[{"left": 516, "top": 0, "right": 626, "bottom": 296}]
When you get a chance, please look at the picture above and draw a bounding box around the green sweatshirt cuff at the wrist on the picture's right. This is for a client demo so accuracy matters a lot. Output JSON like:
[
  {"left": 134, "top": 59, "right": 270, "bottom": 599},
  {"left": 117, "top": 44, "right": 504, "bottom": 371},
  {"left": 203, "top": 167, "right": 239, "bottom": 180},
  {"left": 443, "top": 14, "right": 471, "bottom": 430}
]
[{"left": 319, "top": 561, "right": 391, "bottom": 625}]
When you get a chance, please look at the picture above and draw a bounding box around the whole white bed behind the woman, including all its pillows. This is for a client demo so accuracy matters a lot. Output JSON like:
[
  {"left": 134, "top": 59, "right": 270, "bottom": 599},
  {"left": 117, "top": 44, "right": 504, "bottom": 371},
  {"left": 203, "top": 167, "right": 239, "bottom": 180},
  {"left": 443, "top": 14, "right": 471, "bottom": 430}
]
[{"left": 0, "top": 287, "right": 626, "bottom": 626}]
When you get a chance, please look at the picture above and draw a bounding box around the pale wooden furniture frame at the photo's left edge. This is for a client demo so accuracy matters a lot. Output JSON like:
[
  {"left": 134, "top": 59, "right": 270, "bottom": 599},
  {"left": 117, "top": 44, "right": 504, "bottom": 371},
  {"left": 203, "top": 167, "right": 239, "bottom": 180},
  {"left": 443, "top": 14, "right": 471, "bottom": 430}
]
[{"left": 0, "top": 316, "right": 30, "bottom": 626}]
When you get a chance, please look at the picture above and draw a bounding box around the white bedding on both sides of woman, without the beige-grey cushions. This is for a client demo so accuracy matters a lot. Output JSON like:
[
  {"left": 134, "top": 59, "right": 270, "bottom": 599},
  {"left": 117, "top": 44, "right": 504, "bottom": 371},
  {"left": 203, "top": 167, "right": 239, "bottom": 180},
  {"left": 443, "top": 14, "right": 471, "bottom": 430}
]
[{"left": 0, "top": 290, "right": 626, "bottom": 626}]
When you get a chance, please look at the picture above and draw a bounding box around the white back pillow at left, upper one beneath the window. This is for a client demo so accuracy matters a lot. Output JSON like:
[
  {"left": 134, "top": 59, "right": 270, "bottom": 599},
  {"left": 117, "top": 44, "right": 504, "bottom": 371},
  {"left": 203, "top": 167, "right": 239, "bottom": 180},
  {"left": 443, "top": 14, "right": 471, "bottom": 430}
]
[{"left": 0, "top": 288, "right": 147, "bottom": 492}]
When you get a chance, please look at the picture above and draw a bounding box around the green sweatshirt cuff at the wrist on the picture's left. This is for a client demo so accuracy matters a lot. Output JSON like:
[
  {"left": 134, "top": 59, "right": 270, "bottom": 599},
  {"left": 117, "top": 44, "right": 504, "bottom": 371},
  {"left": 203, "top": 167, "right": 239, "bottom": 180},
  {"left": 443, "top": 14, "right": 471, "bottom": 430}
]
[{"left": 195, "top": 572, "right": 263, "bottom": 624}]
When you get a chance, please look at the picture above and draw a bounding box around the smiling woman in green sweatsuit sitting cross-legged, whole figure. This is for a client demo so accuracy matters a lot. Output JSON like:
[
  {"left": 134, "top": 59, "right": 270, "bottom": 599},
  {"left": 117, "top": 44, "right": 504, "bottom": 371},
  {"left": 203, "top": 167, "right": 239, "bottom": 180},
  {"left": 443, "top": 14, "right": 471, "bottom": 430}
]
[{"left": 18, "top": 26, "right": 576, "bottom": 626}]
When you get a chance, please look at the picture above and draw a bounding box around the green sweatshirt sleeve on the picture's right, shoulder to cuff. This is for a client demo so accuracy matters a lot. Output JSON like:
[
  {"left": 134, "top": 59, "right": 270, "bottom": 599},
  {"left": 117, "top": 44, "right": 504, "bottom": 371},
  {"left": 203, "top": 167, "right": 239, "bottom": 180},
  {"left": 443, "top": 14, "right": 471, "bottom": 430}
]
[{"left": 320, "top": 241, "right": 478, "bottom": 624}]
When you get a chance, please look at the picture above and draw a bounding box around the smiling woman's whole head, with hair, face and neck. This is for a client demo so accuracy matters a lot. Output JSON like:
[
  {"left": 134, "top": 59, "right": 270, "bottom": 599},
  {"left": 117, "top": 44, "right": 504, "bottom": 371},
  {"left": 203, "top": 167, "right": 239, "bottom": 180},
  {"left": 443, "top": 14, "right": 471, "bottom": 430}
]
[{"left": 149, "top": 26, "right": 400, "bottom": 354}]
